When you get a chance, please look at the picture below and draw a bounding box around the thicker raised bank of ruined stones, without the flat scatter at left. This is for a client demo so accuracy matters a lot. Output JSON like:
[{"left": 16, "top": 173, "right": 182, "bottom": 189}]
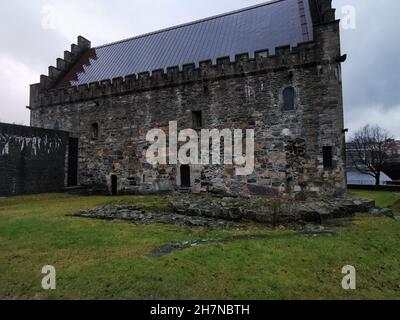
[{"left": 171, "top": 195, "right": 375, "bottom": 225}]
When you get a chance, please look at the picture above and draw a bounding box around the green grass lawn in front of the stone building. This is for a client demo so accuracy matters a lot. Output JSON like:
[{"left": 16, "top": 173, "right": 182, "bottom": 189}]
[{"left": 0, "top": 191, "right": 400, "bottom": 299}]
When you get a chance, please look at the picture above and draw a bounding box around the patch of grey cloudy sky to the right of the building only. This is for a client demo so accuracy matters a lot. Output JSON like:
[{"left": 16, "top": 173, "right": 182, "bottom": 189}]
[{"left": 334, "top": 0, "right": 400, "bottom": 137}]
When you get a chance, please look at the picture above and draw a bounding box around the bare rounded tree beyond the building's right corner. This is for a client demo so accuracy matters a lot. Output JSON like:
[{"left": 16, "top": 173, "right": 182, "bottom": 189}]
[{"left": 348, "top": 125, "right": 394, "bottom": 186}]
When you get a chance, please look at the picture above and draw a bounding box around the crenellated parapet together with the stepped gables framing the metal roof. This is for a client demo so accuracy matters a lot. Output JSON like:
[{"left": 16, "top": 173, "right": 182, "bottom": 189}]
[{"left": 29, "top": 0, "right": 343, "bottom": 109}]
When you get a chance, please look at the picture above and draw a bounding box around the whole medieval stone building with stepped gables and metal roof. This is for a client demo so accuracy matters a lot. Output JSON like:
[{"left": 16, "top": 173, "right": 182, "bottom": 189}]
[{"left": 29, "top": 0, "right": 346, "bottom": 196}]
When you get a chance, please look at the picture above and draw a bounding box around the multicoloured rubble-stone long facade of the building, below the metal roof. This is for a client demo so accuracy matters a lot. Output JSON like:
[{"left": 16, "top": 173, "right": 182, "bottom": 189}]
[{"left": 30, "top": 21, "right": 346, "bottom": 197}]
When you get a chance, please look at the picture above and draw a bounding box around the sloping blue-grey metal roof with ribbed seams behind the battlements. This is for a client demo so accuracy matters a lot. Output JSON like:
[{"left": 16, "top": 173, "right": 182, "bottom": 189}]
[{"left": 58, "top": 0, "right": 313, "bottom": 86}]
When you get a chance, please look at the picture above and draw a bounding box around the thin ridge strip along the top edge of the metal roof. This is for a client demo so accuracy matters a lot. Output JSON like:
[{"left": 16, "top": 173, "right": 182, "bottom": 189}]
[{"left": 93, "top": 0, "right": 287, "bottom": 49}]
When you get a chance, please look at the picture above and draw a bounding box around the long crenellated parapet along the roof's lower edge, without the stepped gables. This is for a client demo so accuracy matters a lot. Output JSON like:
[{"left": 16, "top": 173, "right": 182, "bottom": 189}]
[{"left": 30, "top": 42, "right": 329, "bottom": 109}]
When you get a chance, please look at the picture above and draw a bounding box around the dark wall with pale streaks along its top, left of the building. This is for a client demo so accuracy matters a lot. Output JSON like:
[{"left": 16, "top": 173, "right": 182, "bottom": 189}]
[{"left": 0, "top": 123, "right": 68, "bottom": 196}]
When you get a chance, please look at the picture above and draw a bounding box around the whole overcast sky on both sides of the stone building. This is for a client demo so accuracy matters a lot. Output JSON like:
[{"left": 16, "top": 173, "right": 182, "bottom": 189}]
[{"left": 0, "top": 0, "right": 400, "bottom": 138}]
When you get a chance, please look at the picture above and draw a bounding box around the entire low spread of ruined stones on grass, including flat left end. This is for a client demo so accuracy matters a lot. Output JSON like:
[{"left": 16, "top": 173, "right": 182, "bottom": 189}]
[{"left": 73, "top": 195, "right": 386, "bottom": 229}]
